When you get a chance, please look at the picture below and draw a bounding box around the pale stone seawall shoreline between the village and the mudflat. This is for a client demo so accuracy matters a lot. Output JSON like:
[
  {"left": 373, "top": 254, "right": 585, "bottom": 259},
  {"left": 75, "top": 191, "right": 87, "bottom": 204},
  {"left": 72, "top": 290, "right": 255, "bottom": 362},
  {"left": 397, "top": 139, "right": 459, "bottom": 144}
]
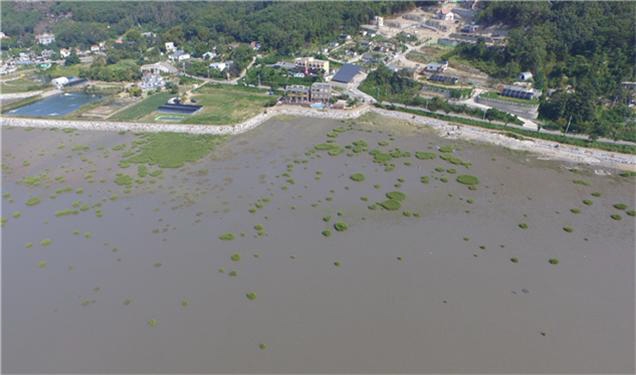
[{"left": 0, "top": 105, "right": 636, "bottom": 171}]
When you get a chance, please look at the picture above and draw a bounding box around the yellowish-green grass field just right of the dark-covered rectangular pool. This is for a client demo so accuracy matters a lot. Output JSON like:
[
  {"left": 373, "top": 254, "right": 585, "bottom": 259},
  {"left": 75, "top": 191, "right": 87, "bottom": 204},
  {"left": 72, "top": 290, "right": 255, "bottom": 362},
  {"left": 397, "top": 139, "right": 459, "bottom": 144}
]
[{"left": 183, "top": 84, "right": 275, "bottom": 125}]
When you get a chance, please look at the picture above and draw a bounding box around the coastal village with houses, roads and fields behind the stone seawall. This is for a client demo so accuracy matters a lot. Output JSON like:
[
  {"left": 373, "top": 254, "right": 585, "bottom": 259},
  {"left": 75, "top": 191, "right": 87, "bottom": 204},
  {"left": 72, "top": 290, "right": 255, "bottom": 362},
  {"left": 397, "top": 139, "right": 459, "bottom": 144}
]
[{"left": 0, "top": 1, "right": 636, "bottom": 153}]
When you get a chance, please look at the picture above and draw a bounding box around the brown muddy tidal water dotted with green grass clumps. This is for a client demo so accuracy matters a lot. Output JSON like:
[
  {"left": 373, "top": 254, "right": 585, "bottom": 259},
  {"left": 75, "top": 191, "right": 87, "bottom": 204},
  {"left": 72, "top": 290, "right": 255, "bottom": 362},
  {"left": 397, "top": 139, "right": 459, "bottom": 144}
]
[{"left": 2, "top": 117, "right": 635, "bottom": 373}]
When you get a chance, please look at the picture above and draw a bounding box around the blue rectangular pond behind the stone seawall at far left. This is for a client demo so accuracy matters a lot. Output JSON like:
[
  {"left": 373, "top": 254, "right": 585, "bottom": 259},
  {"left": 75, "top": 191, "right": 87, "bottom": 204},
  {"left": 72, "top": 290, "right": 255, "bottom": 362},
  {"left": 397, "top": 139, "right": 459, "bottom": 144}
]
[{"left": 8, "top": 92, "right": 101, "bottom": 117}]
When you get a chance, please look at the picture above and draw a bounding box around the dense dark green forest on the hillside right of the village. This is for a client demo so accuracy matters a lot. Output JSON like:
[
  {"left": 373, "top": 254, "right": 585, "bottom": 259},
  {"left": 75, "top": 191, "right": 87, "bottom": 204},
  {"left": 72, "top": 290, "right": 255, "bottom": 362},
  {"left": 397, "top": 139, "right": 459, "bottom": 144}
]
[{"left": 454, "top": 1, "right": 636, "bottom": 140}]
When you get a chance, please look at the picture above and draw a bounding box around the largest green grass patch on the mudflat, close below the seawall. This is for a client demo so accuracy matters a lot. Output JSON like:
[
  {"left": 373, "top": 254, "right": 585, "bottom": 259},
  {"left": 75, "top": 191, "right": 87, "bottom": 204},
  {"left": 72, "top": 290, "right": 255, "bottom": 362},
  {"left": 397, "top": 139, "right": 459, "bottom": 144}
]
[{"left": 125, "top": 133, "right": 226, "bottom": 168}]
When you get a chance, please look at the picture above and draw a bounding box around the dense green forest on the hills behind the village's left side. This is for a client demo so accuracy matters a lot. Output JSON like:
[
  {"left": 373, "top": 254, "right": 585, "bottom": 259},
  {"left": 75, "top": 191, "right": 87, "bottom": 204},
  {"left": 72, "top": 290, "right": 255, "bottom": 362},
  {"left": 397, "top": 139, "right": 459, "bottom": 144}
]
[{"left": 2, "top": 1, "right": 414, "bottom": 54}]
